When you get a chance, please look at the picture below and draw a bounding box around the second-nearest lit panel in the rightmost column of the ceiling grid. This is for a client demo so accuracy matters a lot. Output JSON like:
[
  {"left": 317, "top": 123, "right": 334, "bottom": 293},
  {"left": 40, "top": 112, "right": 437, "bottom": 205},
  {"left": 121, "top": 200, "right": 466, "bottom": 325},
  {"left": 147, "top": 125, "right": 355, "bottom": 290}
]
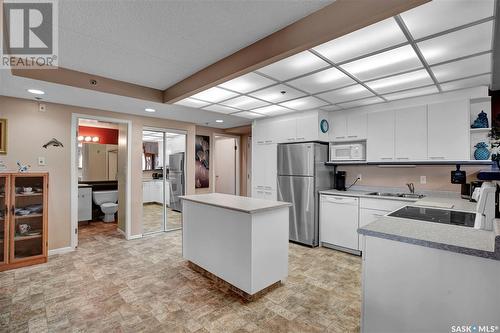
[{"left": 417, "top": 21, "right": 493, "bottom": 65}]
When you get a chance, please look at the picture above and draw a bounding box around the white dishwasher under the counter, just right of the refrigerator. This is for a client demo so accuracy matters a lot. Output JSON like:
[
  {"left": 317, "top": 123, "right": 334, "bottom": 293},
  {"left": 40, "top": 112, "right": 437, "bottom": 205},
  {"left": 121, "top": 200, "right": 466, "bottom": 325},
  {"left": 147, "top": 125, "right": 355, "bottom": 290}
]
[{"left": 319, "top": 195, "right": 359, "bottom": 253}]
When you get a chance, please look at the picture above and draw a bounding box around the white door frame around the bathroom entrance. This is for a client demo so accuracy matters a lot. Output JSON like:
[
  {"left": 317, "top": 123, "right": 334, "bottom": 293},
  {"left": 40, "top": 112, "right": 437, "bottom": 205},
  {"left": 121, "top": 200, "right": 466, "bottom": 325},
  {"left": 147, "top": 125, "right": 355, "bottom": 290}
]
[{"left": 70, "top": 113, "right": 133, "bottom": 249}]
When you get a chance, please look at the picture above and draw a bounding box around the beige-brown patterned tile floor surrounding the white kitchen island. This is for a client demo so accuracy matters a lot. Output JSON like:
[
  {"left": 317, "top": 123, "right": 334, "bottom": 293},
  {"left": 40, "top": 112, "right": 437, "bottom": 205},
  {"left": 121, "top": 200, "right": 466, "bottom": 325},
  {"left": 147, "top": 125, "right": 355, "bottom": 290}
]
[{"left": 0, "top": 222, "right": 361, "bottom": 333}]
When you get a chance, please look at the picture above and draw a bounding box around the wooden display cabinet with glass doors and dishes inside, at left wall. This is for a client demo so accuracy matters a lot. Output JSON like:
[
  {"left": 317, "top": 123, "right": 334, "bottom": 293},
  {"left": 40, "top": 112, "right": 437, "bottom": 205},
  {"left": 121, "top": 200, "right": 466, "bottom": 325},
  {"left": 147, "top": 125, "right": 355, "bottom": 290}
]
[{"left": 0, "top": 173, "right": 49, "bottom": 271}]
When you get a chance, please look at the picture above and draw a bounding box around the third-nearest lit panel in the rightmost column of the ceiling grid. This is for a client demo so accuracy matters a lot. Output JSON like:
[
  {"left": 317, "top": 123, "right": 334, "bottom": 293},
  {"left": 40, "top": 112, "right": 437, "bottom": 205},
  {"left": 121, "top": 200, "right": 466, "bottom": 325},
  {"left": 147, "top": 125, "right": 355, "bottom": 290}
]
[{"left": 431, "top": 53, "right": 491, "bottom": 82}]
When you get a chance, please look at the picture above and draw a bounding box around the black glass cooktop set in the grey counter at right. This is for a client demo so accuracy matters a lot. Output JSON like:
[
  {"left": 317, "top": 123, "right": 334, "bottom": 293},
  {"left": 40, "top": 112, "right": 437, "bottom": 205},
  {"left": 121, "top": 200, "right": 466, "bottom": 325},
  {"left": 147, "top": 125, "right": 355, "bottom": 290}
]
[{"left": 388, "top": 206, "right": 476, "bottom": 227}]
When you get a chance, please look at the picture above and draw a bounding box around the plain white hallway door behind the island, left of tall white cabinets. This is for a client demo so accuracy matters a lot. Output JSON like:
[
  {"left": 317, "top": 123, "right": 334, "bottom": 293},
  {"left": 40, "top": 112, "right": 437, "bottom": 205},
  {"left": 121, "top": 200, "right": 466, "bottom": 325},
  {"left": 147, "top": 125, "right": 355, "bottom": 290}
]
[{"left": 214, "top": 135, "right": 240, "bottom": 195}]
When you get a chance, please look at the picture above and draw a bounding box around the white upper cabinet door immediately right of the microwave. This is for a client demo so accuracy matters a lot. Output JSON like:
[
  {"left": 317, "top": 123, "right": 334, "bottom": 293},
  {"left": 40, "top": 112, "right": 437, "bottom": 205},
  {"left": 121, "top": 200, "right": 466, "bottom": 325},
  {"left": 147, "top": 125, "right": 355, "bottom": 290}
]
[{"left": 366, "top": 110, "right": 394, "bottom": 162}]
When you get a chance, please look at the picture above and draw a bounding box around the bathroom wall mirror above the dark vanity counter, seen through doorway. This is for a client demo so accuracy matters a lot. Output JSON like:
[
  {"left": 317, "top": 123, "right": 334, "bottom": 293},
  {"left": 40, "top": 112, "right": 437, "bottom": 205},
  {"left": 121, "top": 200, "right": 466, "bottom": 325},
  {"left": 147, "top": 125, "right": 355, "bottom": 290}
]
[{"left": 78, "top": 143, "right": 118, "bottom": 181}]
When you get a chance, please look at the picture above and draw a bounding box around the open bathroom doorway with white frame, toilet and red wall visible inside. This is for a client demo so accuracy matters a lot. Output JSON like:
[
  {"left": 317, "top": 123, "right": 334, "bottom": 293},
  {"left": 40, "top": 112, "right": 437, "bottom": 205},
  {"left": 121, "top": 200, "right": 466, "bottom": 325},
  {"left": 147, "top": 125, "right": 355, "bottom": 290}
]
[{"left": 70, "top": 114, "right": 132, "bottom": 248}]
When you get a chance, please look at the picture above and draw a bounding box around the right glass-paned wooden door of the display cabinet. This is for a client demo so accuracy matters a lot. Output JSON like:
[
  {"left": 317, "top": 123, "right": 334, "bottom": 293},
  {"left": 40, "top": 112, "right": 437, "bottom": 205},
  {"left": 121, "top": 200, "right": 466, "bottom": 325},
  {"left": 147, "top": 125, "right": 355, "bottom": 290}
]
[{"left": 9, "top": 174, "right": 48, "bottom": 263}]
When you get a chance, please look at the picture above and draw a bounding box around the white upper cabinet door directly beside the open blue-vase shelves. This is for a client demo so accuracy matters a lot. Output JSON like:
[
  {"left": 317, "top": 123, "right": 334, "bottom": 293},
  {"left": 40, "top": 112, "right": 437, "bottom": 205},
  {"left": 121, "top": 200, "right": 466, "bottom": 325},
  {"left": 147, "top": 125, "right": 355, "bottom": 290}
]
[{"left": 427, "top": 100, "right": 470, "bottom": 161}]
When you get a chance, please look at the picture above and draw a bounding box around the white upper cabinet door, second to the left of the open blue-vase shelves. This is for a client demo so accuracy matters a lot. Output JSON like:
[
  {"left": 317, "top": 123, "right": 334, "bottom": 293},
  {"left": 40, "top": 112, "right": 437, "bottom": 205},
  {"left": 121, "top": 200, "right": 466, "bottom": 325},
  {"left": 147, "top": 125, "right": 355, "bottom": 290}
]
[{"left": 394, "top": 105, "right": 427, "bottom": 162}]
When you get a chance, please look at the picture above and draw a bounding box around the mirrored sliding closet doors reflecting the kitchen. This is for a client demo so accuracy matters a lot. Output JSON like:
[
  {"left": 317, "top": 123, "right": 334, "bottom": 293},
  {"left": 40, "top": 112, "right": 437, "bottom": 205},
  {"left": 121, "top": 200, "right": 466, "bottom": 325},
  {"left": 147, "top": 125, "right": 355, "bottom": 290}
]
[{"left": 142, "top": 127, "right": 186, "bottom": 234}]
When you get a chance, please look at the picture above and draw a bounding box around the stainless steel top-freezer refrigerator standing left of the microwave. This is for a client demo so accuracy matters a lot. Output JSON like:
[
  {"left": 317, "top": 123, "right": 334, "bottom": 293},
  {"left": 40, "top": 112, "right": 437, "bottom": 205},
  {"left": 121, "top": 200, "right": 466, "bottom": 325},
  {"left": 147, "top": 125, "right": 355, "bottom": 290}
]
[{"left": 278, "top": 142, "right": 333, "bottom": 246}]
